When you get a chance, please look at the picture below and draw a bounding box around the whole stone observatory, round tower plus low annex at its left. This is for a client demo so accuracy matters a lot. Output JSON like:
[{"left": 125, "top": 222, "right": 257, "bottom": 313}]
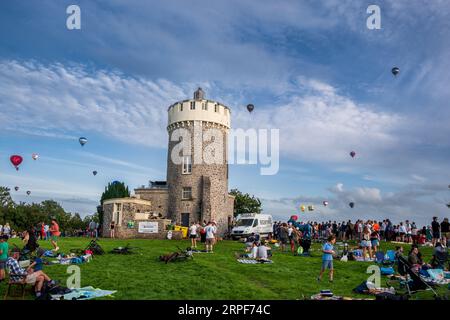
[{"left": 103, "top": 88, "right": 234, "bottom": 238}]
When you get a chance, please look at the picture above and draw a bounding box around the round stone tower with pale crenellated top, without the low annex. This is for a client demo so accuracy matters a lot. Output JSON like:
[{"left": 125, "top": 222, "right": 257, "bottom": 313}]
[{"left": 167, "top": 88, "right": 234, "bottom": 233}]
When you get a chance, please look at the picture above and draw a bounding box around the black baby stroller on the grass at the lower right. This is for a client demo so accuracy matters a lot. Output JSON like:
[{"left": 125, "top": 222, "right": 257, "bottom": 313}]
[{"left": 388, "top": 256, "right": 438, "bottom": 298}]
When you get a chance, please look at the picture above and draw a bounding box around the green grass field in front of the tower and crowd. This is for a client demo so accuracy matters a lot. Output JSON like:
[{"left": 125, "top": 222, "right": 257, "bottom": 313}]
[{"left": 0, "top": 238, "right": 448, "bottom": 300}]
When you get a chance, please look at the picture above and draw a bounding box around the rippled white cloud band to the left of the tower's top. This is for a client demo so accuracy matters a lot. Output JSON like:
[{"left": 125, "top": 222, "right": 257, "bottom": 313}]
[{"left": 0, "top": 61, "right": 188, "bottom": 147}]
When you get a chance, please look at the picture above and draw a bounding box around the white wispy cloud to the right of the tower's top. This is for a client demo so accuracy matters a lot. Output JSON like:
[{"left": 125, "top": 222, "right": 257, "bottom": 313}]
[{"left": 233, "top": 78, "right": 407, "bottom": 164}]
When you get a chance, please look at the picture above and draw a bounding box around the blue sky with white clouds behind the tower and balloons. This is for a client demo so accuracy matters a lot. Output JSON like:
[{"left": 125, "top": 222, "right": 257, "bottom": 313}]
[{"left": 0, "top": 0, "right": 450, "bottom": 224}]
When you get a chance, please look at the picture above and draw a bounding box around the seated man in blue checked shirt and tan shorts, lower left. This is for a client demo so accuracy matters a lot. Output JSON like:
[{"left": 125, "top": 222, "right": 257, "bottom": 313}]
[{"left": 6, "top": 250, "right": 55, "bottom": 297}]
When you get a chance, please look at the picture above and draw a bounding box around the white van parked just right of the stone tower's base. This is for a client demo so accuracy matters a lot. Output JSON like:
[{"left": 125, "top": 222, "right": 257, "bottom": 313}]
[{"left": 231, "top": 213, "right": 273, "bottom": 239}]
